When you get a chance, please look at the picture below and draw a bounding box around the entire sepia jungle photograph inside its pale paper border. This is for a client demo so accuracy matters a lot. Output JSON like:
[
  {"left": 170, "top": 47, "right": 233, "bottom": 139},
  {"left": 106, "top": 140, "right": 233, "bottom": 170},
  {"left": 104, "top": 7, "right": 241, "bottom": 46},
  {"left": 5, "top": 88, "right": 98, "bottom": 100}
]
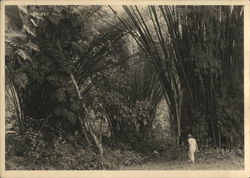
[{"left": 1, "top": 2, "right": 245, "bottom": 171}]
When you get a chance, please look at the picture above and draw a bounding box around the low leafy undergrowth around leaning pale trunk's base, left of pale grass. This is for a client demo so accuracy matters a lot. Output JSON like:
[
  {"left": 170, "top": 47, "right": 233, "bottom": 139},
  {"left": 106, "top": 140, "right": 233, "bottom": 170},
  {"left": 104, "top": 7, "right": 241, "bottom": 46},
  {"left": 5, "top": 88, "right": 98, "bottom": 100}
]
[{"left": 6, "top": 130, "right": 147, "bottom": 170}]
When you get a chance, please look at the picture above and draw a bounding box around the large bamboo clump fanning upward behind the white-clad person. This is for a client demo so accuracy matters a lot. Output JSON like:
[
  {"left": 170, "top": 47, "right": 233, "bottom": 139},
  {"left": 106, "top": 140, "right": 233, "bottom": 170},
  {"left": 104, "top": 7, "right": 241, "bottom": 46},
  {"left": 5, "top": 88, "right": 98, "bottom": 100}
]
[{"left": 111, "top": 6, "right": 243, "bottom": 147}]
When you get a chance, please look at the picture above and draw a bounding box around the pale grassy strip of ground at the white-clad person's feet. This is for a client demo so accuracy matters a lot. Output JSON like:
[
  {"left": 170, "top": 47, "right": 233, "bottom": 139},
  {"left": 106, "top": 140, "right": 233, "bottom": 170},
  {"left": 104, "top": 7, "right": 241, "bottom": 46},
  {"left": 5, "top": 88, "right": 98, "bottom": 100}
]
[{"left": 121, "top": 151, "right": 244, "bottom": 170}]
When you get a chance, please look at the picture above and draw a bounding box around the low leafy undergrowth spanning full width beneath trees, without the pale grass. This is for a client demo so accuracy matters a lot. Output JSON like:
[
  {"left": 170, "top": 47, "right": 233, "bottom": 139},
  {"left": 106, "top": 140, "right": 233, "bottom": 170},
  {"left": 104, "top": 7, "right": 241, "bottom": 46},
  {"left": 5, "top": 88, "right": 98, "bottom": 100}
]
[{"left": 6, "top": 130, "right": 244, "bottom": 170}]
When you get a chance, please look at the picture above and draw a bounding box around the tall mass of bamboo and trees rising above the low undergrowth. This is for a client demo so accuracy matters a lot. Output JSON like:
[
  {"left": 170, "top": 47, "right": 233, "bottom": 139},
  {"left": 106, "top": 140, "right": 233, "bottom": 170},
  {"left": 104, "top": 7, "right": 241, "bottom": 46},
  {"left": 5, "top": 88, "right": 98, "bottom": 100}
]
[{"left": 5, "top": 6, "right": 244, "bottom": 165}]
